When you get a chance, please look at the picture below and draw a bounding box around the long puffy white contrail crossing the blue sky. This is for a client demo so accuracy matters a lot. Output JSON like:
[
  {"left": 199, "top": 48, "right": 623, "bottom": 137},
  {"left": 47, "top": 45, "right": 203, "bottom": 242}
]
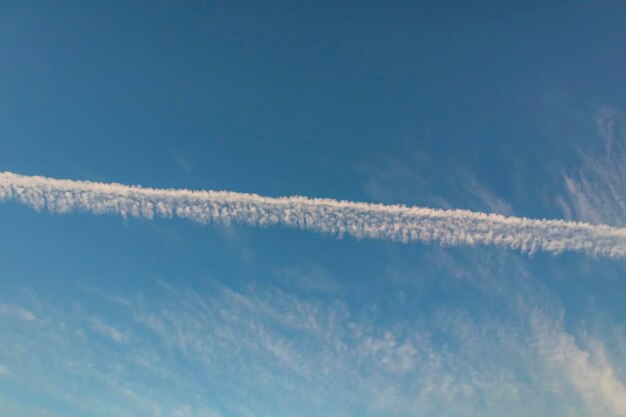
[{"left": 0, "top": 172, "right": 626, "bottom": 258}]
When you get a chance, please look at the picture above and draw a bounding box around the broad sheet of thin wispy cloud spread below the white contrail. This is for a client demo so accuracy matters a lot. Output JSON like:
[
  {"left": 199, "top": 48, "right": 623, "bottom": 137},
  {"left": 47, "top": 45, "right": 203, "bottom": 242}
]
[{"left": 0, "top": 251, "right": 626, "bottom": 417}]
